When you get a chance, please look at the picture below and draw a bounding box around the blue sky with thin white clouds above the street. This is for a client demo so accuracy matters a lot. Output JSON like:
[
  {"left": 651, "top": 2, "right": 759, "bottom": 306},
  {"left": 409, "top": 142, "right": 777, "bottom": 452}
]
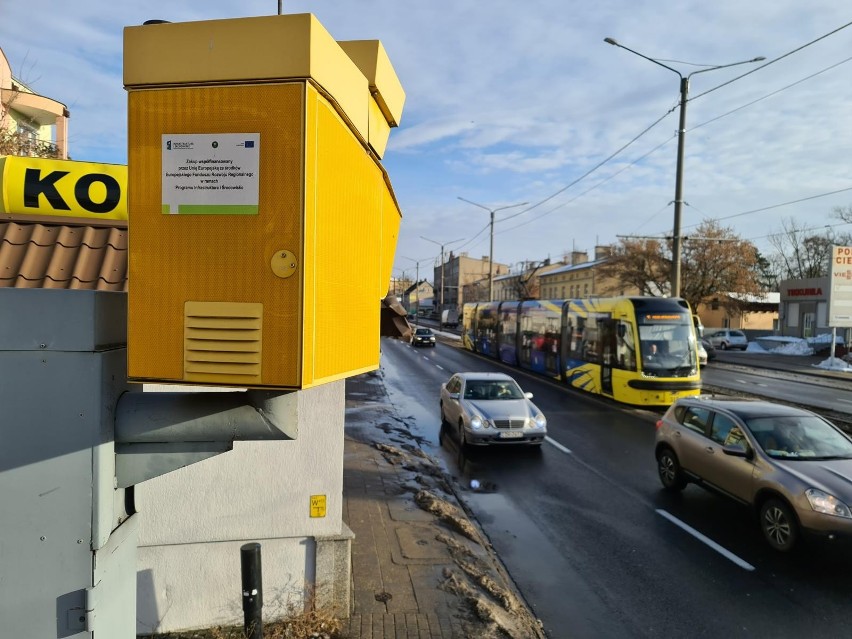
[{"left": 0, "top": 0, "right": 852, "bottom": 281}]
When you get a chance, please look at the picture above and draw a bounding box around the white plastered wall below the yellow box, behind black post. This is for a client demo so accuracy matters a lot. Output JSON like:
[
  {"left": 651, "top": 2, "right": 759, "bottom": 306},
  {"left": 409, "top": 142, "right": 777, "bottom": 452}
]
[{"left": 135, "top": 381, "right": 345, "bottom": 634}]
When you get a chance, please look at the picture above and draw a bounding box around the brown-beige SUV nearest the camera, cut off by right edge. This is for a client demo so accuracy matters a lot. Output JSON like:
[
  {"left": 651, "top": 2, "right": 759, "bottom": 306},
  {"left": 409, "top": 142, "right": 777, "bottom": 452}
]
[{"left": 655, "top": 396, "right": 852, "bottom": 552}]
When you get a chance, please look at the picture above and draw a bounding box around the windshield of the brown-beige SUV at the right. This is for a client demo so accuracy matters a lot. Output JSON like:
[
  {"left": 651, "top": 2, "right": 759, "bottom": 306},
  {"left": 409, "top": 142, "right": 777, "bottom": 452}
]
[{"left": 746, "top": 415, "right": 852, "bottom": 459}]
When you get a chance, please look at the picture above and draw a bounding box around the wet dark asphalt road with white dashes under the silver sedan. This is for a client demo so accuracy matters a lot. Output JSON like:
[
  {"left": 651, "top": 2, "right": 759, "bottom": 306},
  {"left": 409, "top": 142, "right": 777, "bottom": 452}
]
[{"left": 382, "top": 340, "right": 852, "bottom": 639}]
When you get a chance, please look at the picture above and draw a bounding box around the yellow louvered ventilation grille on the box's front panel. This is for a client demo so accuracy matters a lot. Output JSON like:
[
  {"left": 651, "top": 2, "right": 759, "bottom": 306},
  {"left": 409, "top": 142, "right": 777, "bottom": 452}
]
[{"left": 183, "top": 302, "right": 263, "bottom": 386}]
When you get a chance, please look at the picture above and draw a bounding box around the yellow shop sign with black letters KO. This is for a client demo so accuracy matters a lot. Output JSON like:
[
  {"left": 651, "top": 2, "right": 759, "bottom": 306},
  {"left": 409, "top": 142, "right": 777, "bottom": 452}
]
[{"left": 0, "top": 155, "right": 127, "bottom": 220}]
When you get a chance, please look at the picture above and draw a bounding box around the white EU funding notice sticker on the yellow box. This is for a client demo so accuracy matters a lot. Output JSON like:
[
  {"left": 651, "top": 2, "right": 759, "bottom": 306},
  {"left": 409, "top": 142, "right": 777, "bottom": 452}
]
[{"left": 162, "top": 133, "right": 260, "bottom": 215}]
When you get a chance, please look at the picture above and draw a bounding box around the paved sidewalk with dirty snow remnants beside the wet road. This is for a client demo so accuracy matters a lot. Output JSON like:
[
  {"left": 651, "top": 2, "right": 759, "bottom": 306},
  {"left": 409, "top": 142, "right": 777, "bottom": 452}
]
[{"left": 343, "top": 371, "right": 545, "bottom": 639}]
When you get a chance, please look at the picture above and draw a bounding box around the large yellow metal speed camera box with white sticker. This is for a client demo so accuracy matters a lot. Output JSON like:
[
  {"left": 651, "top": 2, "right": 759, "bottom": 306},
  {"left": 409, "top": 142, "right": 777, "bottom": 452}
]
[{"left": 124, "top": 14, "right": 404, "bottom": 389}]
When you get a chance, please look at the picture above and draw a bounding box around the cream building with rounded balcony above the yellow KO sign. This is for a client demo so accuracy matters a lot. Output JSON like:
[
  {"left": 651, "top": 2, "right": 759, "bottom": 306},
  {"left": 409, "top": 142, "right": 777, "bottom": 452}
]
[{"left": 0, "top": 49, "right": 71, "bottom": 160}]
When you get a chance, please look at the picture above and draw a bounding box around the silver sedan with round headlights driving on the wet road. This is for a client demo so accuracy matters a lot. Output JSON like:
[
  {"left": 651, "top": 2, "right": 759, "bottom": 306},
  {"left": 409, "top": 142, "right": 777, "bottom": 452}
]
[{"left": 440, "top": 373, "right": 547, "bottom": 447}]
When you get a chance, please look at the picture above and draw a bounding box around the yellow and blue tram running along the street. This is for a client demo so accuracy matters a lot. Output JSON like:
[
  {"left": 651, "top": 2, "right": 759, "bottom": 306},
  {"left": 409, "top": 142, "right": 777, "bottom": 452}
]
[{"left": 462, "top": 297, "right": 701, "bottom": 406}]
